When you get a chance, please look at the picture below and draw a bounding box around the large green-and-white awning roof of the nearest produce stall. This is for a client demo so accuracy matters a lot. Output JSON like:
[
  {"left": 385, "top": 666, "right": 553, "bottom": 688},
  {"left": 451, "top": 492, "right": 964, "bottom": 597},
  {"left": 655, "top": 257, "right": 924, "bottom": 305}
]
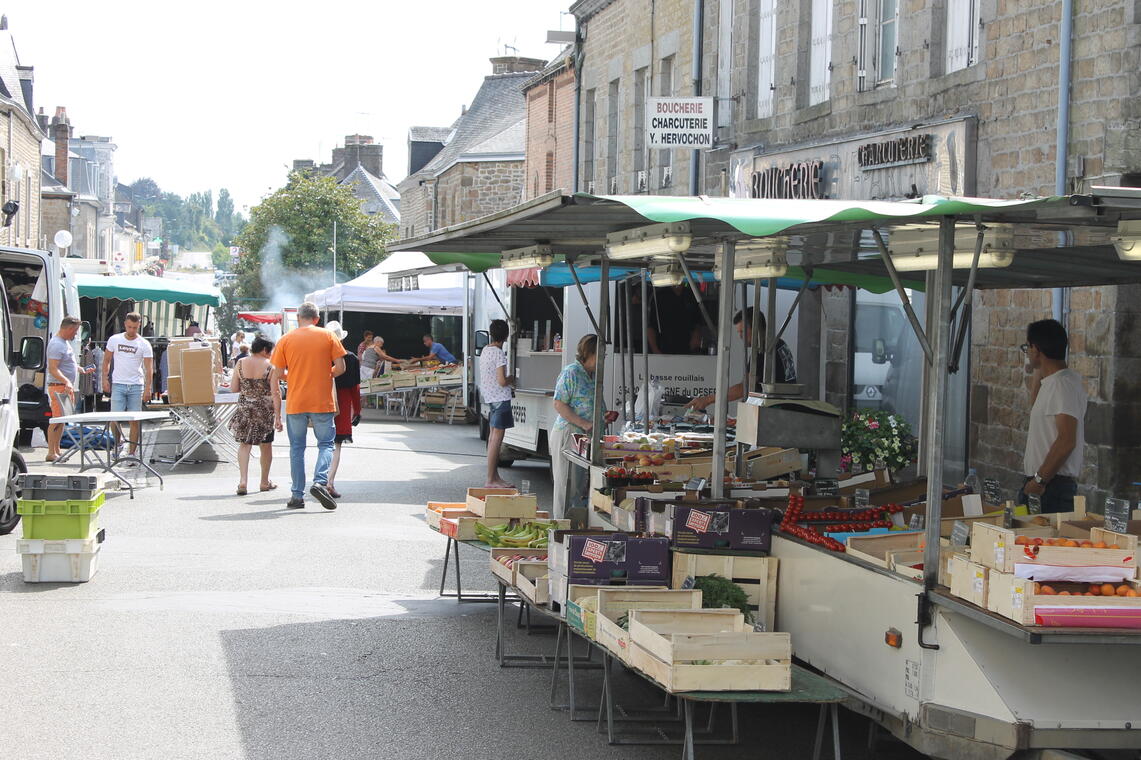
[{"left": 391, "top": 188, "right": 1141, "bottom": 288}]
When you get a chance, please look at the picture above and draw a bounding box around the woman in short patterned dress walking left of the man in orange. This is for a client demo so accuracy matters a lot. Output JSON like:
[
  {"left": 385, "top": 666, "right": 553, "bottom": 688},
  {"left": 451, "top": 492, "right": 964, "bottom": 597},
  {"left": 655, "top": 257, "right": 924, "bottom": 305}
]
[{"left": 229, "top": 338, "right": 282, "bottom": 496}]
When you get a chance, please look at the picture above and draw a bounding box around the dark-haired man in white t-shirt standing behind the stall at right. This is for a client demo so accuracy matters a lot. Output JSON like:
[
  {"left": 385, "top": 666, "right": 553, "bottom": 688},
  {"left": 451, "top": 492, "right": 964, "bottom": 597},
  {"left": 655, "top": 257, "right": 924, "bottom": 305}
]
[{"left": 1019, "top": 320, "right": 1089, "bottom": 512}]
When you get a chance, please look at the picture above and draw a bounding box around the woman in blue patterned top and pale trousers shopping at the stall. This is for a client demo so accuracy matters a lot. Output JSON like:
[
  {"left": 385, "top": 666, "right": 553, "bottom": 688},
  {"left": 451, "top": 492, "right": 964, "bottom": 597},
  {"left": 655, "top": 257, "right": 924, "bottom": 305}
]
[{"left": 549, "top": 333, "right": 618, "bottom": 518}]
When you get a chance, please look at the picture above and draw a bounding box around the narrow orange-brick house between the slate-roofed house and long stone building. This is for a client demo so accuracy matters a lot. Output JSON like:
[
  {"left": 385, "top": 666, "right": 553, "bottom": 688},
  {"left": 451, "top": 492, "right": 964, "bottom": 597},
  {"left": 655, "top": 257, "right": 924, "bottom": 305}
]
[{"left": 523, "top": 48, "right": 574, "bottom": 200}]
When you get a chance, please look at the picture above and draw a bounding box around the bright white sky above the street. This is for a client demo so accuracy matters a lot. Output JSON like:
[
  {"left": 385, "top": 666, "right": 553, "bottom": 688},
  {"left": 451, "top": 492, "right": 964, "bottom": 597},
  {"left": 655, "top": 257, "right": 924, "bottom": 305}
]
[{"left": 11, "top": 0, "right": 574, "bottom": 210}]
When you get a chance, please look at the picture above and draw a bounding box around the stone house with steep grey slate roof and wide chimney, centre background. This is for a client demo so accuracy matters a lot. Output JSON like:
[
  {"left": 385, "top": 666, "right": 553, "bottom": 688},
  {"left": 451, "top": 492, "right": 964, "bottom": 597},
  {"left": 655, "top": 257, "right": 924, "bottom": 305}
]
[{"left": 397, "top": 56, "right": 547, "bottom": 237}]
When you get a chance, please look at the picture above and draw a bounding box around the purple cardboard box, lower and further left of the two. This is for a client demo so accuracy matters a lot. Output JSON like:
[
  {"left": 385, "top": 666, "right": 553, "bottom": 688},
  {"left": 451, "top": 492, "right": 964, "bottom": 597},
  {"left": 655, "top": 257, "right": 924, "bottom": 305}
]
[{"left": 567, "top": 533, "right": 670, "bottom": 581}]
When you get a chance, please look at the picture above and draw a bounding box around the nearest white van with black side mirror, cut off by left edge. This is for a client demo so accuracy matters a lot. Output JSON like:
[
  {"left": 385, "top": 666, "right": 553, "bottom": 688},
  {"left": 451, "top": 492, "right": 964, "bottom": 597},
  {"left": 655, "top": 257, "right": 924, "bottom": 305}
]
[{"left": 0, "top": 265, "right": 44, "bottom": 535}]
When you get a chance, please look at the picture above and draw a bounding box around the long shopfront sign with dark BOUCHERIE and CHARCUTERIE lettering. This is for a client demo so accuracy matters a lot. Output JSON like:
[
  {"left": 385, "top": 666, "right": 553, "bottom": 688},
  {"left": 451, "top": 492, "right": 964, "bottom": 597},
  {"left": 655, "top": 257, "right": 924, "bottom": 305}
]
[{"left": 725, "top": 118, "right": 976, "bottom": 200}]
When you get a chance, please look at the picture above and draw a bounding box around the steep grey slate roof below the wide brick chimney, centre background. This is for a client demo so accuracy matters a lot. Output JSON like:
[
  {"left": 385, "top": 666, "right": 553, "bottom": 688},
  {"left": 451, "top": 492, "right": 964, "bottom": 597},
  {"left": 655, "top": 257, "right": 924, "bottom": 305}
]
[{"left": 416, "top": 72, "right": 535, "bottom": 175}]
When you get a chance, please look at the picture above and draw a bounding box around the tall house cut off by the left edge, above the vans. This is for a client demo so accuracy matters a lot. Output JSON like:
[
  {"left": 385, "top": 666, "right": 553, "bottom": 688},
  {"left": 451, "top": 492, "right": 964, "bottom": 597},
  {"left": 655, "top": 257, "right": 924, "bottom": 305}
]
[{"left": 0, "top": 17, "right": 43, "bottom": 248}]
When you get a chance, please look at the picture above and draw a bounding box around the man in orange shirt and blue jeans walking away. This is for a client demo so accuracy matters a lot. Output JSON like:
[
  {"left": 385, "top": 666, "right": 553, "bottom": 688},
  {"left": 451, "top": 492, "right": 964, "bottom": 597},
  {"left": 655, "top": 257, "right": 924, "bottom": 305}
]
[{"left": 269, "top": 301, "right": 346, "bottom": 509}]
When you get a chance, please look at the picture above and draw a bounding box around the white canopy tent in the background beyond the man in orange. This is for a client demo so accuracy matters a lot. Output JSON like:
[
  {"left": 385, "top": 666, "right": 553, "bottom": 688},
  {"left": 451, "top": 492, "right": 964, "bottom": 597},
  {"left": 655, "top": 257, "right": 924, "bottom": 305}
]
[{"left": 305, "top": 251, "right": 467, "bottom": 316}]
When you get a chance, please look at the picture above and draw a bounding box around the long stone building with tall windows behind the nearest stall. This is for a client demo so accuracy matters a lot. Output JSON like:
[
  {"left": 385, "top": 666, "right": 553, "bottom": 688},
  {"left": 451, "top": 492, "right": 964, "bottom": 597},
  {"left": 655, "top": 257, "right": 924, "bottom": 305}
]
[{"left": 572, "top": 0, "right": 1141, "bottom": 499}]
